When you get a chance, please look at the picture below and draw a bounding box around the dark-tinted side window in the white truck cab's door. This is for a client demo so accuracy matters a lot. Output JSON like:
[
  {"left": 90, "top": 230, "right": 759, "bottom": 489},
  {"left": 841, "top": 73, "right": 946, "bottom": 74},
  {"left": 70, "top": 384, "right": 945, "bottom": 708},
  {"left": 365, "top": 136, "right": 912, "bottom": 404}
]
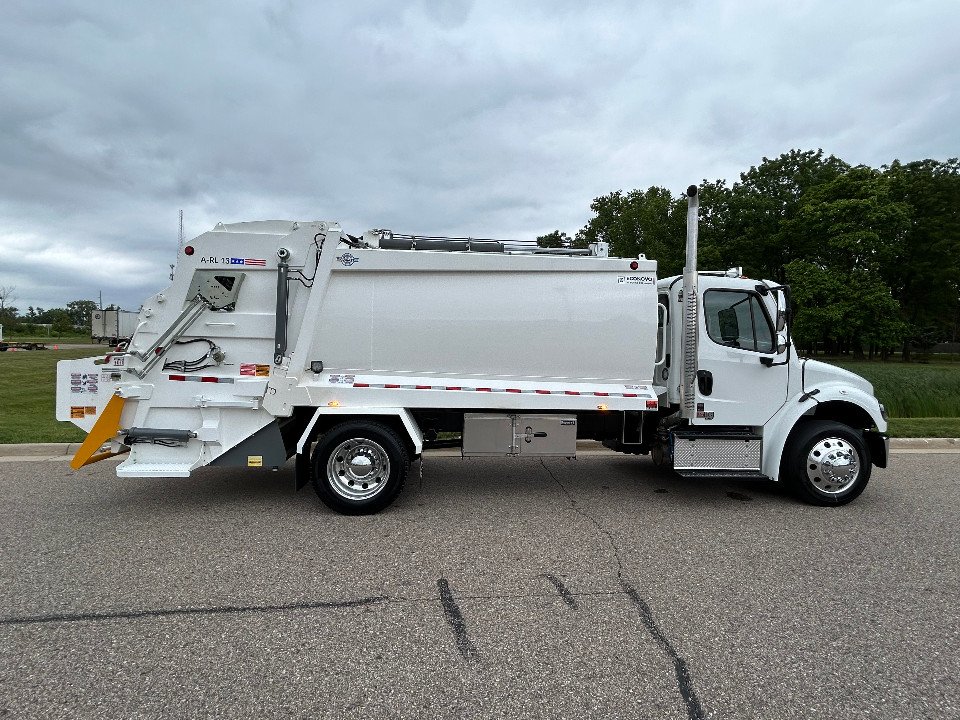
[{"left": 703, "top": 290, "right": 774, "bottom": 353}]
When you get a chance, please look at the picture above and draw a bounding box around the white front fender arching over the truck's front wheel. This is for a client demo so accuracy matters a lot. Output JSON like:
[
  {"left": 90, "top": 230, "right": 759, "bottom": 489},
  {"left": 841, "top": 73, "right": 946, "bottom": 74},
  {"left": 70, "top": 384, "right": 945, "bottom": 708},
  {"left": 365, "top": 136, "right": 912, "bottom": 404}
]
[{"left": 762, "top": 383, "right": 887, "bottom": 481}]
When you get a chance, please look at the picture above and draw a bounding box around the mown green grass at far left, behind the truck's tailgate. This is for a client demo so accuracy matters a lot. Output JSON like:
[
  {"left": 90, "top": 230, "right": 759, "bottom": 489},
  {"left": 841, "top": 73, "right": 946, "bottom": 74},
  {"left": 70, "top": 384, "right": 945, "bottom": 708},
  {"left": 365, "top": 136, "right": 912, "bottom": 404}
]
[{"left": 0, "top": 348, "right": 97, "bottom": 443}]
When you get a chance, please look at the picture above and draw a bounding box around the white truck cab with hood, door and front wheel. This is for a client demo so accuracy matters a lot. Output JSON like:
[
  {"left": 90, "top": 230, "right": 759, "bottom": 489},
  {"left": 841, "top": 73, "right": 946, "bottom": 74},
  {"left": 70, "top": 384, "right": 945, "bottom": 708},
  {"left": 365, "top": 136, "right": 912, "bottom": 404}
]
[{"left": 653, "top": 268, "right": 888, "bottom": 504}]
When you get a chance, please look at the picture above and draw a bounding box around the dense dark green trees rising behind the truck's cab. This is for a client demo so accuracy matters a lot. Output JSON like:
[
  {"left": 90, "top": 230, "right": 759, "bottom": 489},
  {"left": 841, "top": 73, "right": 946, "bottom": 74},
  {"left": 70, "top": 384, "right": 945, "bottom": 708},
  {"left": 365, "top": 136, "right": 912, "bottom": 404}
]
[{"left": 537, "top": 150, "right": 960, "bottom": 360}]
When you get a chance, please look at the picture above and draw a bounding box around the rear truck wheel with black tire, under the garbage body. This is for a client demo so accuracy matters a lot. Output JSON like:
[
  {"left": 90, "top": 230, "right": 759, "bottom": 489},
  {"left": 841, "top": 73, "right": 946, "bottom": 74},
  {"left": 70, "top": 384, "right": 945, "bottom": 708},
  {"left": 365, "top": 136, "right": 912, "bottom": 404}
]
[{"left": 311, "top": 421, "right": 410, "bottom": 515}]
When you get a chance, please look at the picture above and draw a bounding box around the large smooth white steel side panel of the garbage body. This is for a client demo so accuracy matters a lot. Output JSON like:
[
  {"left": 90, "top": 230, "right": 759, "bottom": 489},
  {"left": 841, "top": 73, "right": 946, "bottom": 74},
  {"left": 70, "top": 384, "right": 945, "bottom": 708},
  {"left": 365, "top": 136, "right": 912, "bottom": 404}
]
[{"left": 311, "top": 250, "right": 657, "bottom": 382}]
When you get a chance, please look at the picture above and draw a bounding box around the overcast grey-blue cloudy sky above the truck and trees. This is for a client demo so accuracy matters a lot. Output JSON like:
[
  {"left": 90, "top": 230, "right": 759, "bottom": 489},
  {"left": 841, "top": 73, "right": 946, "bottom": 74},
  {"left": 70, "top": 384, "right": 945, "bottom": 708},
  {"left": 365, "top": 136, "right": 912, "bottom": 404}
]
[{"left": 0, "top": 0, "right": 960, "bottom": 309}]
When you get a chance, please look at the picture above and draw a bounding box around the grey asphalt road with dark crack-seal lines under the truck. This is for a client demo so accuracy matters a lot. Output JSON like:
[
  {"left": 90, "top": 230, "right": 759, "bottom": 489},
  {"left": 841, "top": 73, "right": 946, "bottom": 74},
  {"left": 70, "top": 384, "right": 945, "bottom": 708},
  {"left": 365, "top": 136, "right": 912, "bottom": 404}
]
[{"left": 0, "top": 454, "right": 960, "bottom": 719}]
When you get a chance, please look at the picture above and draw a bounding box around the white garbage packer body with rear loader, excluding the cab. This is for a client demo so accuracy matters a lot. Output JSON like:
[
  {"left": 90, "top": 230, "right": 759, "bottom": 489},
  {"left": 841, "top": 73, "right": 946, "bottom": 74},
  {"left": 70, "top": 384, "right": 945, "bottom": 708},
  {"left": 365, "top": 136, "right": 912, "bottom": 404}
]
[{"left": 57, "top": 221, "right": 663, "bottom": 476}]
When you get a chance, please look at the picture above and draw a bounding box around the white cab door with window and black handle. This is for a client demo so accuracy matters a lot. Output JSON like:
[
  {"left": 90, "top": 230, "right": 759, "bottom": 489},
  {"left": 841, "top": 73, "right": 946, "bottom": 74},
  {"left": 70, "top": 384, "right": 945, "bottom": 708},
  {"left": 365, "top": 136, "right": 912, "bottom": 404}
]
[{"left": 692, "top": 287, "right": 789, "bottom": 426}]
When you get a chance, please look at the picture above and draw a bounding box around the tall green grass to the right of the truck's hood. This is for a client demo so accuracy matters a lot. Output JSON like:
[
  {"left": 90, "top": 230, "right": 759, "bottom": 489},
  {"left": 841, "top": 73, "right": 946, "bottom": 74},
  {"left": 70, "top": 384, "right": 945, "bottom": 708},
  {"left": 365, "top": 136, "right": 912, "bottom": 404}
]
[{"left": 829, "top": 360, "right": 960, "bottom": 416}]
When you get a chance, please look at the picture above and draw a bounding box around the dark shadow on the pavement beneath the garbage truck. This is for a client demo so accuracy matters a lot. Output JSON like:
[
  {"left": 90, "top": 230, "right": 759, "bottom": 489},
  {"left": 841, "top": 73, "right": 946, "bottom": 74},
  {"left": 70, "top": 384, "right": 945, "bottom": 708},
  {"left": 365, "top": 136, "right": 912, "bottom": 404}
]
[{"left": 95, "top": 456, "right": 796, "bottom": 516}]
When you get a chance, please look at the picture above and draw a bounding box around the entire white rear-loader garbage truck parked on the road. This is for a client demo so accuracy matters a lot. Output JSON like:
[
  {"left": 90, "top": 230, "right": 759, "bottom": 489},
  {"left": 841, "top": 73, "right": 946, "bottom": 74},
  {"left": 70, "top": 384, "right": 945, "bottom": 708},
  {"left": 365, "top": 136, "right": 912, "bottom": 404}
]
[{"left": 57, "top": 187, "right": 888, "bottom": 513}]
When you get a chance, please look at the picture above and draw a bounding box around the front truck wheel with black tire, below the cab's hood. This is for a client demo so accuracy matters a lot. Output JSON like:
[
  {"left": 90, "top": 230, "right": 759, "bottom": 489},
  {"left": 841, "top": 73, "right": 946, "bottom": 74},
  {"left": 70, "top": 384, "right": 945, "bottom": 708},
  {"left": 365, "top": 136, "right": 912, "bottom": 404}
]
[{"left": 780, "top": 420, "right": 872, "bottom": 505}]
